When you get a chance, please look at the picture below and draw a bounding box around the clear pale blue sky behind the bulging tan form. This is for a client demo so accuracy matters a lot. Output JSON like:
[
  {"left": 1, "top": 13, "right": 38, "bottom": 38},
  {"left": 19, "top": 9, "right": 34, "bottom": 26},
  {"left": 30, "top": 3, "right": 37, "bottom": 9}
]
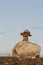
[{"left": 0, "top": 0, "right": 43, "bottom": 55}]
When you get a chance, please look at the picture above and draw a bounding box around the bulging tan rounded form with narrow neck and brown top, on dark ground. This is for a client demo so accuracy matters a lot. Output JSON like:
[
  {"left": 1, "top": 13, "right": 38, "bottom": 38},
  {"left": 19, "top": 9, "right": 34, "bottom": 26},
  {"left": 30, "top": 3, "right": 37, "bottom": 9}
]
[{"left": 12, "top": 30, "right": 41, "bottom": 58}]
